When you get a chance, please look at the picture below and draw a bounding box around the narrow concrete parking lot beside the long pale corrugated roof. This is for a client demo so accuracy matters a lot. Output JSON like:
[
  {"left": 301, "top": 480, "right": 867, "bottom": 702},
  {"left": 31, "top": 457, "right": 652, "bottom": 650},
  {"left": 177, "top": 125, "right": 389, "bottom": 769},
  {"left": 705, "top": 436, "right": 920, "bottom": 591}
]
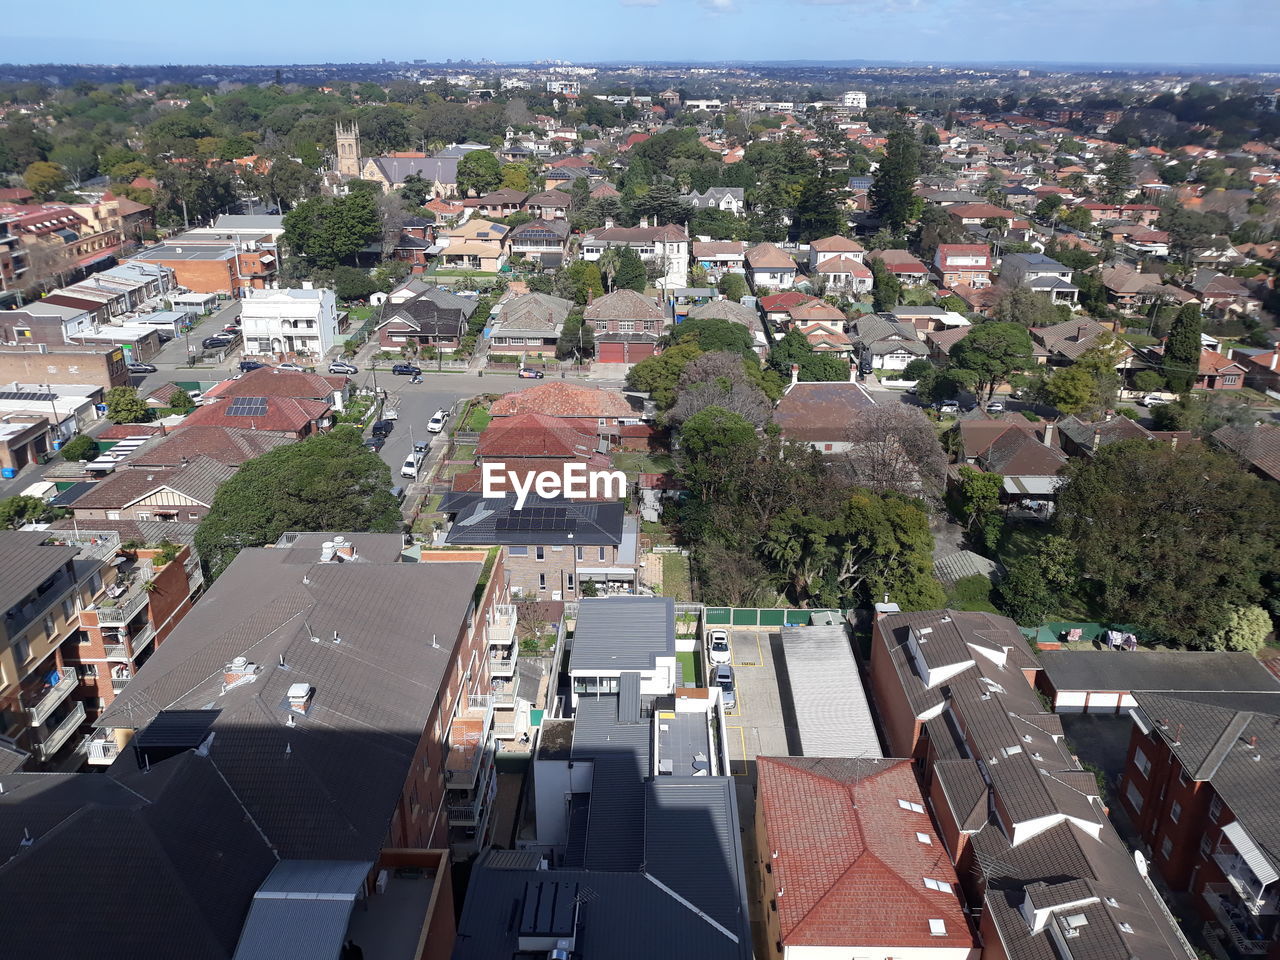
[{"left": 724, "top": 627, "right": 796, "bottom": 785}]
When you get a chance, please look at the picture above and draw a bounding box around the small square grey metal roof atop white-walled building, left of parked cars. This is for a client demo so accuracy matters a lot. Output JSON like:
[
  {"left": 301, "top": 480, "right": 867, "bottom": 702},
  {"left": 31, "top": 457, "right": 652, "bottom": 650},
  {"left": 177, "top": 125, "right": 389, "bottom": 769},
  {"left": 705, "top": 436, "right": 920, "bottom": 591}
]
[{"left": 568, "top": 596, "right": 676, "bottom": 673}]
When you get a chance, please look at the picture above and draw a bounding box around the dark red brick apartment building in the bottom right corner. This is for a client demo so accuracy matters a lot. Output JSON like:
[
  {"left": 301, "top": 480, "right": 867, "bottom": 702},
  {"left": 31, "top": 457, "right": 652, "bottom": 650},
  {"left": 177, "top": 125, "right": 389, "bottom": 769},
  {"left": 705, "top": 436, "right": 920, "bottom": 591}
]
[{"left": 1120, "top": 691, "right": 1280, "bottom": 960}]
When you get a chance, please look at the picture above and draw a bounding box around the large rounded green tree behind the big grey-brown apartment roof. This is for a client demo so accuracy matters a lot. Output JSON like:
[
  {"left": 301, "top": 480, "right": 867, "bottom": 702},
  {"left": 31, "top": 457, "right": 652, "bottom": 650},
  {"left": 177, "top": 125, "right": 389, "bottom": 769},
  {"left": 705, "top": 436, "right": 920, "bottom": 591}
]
[{"left": 196, "top": 426, "right": 402, "bottom": 580}]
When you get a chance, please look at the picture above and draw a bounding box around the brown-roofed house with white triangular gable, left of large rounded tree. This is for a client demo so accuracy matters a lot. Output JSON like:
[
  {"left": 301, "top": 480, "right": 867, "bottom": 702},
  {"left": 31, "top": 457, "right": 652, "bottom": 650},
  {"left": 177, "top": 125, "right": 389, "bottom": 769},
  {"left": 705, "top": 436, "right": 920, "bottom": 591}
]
[{"left": 72, "top": 457, "right": 236, "bottom": 524}]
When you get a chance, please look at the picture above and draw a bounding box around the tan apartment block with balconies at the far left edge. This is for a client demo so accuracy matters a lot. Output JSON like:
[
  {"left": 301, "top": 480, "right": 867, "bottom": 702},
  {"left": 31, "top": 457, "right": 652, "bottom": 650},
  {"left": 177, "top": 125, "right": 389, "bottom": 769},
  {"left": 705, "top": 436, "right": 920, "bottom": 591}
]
[{"left": 0, "top": 530, "right": 119, "bottom": 772}]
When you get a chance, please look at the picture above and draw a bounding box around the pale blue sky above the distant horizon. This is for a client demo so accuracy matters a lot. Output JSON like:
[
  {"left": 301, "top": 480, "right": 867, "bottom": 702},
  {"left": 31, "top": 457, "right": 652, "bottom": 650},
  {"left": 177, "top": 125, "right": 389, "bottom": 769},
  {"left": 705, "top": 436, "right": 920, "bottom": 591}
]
[{"left": 0, "top": 0, "right": 1280, "bottom": 65}]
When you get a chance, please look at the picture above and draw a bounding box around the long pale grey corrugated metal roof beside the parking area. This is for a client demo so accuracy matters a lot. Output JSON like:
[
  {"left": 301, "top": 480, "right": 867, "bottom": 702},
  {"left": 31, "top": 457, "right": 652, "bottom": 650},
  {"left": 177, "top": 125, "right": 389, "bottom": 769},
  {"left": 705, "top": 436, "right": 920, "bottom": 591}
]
[{"left": 782, "top": 625, "right": 884, "bottom": 758}]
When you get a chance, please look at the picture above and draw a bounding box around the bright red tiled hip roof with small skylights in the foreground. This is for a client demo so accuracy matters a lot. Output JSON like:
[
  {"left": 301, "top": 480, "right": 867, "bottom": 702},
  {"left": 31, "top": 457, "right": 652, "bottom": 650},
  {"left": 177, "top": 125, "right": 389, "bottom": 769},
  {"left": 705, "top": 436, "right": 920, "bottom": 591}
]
[{"left": 756, "top": 756, "right": 973, "bottom": 950}]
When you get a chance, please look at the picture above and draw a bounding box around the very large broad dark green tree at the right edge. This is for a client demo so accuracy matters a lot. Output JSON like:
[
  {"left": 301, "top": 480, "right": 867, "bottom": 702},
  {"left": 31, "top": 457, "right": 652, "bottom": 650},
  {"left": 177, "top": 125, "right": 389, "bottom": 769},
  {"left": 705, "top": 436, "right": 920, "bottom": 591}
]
[{"left": 1055, "top": 440, "right": 1280, "bottom": 648}]
